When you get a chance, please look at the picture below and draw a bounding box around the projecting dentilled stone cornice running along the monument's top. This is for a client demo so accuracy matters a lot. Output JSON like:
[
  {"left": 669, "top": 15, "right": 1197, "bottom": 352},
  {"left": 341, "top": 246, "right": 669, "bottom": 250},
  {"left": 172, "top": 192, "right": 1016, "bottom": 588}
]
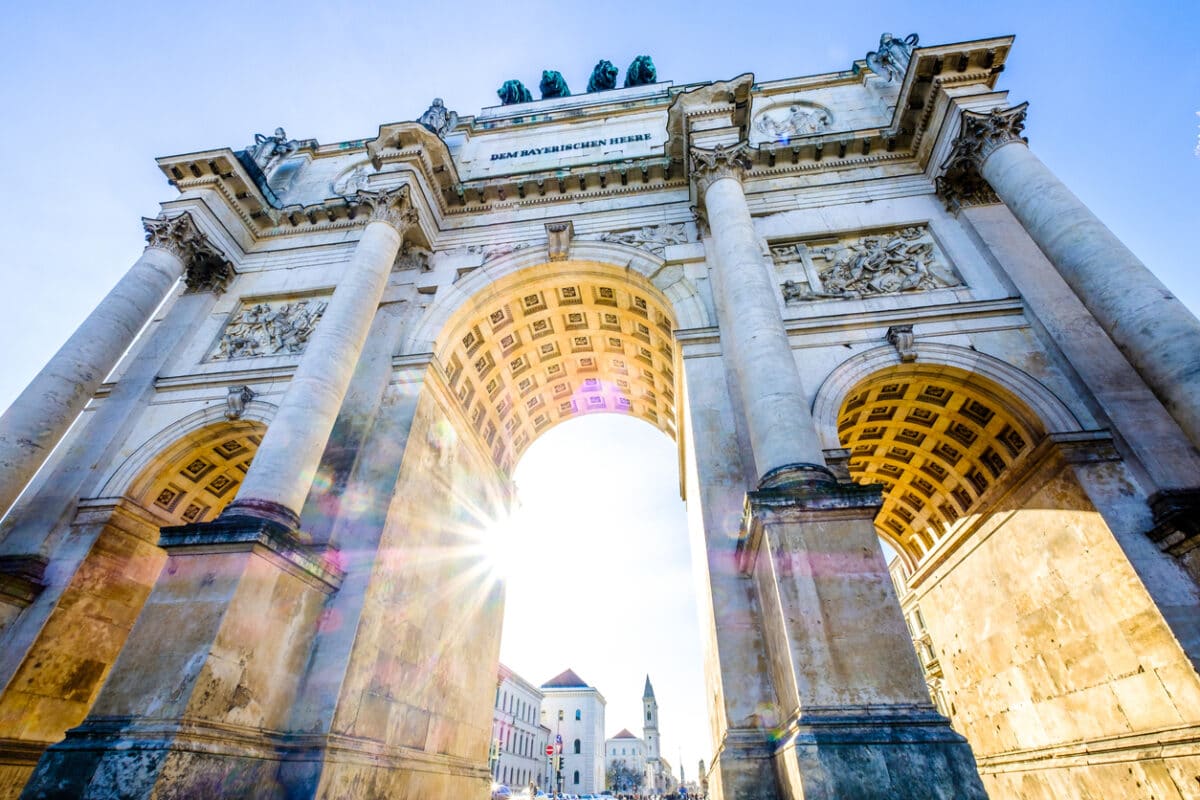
[{"left": 157, "top": 37, "right": 1012, "bottom": 240}]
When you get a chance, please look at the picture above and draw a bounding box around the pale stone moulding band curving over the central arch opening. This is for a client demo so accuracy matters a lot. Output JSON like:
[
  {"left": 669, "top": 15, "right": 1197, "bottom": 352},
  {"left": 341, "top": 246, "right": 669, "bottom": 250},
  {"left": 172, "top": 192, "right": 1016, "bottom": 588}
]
[{"left": 401, "top": 241, "right": 716, "bottom": 354}]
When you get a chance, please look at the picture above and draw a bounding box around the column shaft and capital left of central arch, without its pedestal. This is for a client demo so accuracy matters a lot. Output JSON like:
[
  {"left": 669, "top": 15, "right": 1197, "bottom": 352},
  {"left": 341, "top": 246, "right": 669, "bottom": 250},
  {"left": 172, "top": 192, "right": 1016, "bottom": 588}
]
[{"left": 224, "top": 188, "right": 415, "bottom": 528}]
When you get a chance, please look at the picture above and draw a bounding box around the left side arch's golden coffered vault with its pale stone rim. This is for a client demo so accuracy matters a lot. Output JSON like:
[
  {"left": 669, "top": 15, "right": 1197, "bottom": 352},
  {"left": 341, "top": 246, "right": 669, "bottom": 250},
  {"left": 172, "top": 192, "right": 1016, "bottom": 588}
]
[{"left": 101, "top": 401, "right": 275, "bottom": 525}]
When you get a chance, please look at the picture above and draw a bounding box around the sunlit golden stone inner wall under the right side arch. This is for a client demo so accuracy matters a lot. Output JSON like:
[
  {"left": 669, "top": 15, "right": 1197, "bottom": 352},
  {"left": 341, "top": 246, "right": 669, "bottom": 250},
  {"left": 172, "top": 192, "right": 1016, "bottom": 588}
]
[{"left": 914, "top": 458, "right": 1200, "bottom": 800}]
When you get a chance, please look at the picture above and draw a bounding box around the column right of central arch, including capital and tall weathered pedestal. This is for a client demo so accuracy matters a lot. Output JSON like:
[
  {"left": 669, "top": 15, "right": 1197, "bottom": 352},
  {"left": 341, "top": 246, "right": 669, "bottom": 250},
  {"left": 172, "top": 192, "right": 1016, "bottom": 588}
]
[{"left": 691, "top": 143, "right": 985, "bottom": 800}]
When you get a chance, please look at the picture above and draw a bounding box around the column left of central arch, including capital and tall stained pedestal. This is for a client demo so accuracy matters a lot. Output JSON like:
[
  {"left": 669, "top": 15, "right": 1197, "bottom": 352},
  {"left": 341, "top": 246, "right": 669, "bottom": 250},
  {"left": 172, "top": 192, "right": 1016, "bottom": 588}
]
[{"left": 17, "top": 187, "right": 422, "bottom": 798}]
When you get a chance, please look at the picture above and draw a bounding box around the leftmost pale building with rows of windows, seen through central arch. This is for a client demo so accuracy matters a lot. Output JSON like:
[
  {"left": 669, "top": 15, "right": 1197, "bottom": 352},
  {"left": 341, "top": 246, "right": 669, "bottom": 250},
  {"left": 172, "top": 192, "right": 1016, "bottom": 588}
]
[{"left": 492, "top": 664, "right": 550, "bottom": 787}]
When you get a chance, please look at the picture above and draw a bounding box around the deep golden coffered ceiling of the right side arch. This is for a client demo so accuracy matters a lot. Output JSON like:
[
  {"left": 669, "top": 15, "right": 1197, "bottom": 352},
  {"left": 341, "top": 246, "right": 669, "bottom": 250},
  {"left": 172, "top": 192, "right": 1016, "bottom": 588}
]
[{"left": 838, "top": 366, "right": 1045, "bottom": 567}]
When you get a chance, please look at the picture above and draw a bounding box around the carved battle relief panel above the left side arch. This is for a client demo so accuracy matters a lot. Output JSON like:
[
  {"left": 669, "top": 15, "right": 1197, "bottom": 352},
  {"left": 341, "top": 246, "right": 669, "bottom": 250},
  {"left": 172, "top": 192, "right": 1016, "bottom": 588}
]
[{"left": 209, "top": 297, "right": 329, "bottom": 361}]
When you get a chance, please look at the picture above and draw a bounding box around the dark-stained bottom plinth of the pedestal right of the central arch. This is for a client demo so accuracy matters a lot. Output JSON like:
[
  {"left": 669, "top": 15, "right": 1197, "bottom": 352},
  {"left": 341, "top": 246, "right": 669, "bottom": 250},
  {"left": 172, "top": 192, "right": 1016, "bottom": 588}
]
[{"left": 775, "top": 708, "right": 988, "bottom": 800}]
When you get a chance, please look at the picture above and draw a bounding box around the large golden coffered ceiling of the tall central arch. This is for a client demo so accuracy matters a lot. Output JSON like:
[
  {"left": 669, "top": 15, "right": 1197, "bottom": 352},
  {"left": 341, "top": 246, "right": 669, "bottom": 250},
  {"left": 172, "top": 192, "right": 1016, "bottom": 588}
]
[{"left": 436, "top": 261, "right": 678, "bottom": 473}]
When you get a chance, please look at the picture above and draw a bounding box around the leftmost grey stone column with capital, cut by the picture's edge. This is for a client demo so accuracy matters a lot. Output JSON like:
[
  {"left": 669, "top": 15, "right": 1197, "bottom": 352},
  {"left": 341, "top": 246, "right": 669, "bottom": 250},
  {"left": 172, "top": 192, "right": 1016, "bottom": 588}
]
[{"left": 0, "top": 211, "right": 232, "bottom": 513}]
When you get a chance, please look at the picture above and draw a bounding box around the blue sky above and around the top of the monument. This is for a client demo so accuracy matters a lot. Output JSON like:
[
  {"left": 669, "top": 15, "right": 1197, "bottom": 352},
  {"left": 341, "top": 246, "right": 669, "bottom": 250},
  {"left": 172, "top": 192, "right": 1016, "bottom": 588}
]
[{"left": 0, "top": 0, "right": 1200, "bottom": 786}]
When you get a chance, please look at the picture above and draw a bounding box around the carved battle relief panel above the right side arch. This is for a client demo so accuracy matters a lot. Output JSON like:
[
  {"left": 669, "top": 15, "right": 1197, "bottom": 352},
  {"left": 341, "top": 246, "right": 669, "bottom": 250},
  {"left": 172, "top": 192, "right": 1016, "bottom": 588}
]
[{"left": 770, "top": 225, "right": 962, "bottom": 303}]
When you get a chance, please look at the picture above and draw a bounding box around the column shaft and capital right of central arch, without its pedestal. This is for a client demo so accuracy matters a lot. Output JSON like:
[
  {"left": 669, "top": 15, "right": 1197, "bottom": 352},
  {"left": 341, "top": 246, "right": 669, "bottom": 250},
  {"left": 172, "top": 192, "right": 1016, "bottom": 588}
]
[{"left": 691, "top": 143, "right": 832, "bottom": 486}]
